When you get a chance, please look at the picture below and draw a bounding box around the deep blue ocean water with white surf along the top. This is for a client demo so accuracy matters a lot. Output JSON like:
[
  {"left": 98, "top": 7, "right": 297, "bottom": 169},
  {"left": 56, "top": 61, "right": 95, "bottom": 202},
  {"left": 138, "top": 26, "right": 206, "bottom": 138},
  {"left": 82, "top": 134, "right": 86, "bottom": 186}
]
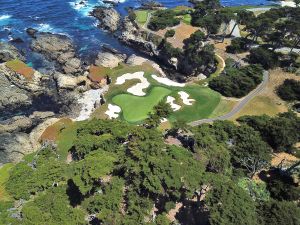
[{"left": 0, "top": 0, "right": 276, "bottom": 64}]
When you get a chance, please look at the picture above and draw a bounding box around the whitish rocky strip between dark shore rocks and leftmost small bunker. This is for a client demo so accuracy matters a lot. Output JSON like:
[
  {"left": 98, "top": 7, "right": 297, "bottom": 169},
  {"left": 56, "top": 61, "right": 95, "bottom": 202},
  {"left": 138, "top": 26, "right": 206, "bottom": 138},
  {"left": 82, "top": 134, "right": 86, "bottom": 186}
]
[{"left": 75, "top": 89, "right": 105, "bottom": 121}]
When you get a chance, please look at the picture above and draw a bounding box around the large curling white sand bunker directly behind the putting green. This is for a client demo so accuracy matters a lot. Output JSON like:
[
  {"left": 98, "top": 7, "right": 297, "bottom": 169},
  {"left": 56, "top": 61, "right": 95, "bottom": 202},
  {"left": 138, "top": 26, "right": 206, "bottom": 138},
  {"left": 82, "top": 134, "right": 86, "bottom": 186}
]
[{"left": 116, "top": 72, "right": 150, "bottom": 96}]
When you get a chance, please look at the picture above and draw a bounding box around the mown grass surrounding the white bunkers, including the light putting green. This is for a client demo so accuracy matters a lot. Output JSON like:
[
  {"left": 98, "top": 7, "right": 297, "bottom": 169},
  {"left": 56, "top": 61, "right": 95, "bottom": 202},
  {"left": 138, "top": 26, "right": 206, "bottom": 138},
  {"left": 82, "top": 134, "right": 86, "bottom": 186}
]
[{"left": 93, "top": 63, "right": 225, "bottom": 123}]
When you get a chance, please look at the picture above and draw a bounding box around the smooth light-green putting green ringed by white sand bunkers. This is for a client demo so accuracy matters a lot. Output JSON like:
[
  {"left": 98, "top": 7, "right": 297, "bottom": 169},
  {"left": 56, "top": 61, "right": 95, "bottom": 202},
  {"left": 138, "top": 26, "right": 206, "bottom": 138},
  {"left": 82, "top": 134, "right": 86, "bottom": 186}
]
[{"left": 112, "top": 87, "right": 172, "bottom": 123}]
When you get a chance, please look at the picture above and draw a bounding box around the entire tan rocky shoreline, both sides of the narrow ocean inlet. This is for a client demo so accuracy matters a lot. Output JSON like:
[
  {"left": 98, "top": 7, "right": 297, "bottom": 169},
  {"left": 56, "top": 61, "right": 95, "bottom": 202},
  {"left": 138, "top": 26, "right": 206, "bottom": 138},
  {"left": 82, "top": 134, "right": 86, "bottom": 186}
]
[{"left": 0, "top": 3, "right": 216, "bottom": 163}]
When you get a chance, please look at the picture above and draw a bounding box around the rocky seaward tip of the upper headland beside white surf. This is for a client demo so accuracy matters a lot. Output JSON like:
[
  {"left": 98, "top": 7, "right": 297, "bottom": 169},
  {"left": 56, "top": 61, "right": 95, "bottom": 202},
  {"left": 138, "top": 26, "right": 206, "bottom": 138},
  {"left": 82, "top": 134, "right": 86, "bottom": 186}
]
[{"left": 91, "top": 7, "right": 121, "bottom": 32}]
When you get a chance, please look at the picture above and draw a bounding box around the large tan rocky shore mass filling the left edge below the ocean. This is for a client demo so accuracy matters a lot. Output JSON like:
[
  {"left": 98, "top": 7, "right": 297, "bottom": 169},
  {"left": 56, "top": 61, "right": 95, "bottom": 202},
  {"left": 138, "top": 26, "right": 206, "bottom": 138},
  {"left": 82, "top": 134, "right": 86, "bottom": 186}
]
[{"left": 0, "top": 30, "right": 100, "bottom": 164}]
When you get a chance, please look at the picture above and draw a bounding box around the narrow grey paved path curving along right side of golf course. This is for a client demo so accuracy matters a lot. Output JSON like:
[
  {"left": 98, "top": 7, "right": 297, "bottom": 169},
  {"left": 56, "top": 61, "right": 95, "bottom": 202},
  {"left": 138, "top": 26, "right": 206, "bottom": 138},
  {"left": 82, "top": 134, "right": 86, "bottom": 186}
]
[{"left": 188, "top": 71, "right": 269, "bottom": 127}]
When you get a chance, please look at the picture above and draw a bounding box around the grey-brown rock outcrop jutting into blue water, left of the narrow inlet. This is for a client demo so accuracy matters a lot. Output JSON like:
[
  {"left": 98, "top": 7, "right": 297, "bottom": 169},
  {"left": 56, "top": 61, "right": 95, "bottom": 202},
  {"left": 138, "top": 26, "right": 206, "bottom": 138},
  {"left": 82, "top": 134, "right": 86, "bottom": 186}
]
[{"left": 31, "top": 33, "right": 83, "bottom": 75}]
